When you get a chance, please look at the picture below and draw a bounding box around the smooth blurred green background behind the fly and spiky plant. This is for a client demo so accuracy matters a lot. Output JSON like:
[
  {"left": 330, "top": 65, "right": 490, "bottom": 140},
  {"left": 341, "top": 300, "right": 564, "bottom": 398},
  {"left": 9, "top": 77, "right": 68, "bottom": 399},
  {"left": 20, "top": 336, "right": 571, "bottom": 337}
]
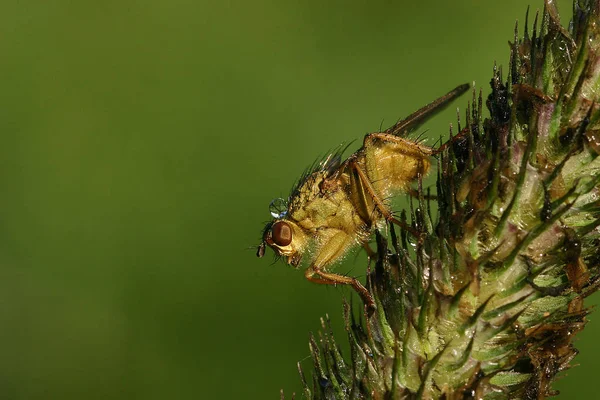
[{"left": 0, "top": 0, "right": 600, "bottom": 399}]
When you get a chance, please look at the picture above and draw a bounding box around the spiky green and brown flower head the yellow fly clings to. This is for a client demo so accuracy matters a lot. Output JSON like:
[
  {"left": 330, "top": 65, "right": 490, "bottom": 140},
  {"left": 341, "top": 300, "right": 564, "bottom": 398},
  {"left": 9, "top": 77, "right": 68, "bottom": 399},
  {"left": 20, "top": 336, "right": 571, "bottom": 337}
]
[{"left": 300, "top": 0, "right": 600, "bottom": 399}]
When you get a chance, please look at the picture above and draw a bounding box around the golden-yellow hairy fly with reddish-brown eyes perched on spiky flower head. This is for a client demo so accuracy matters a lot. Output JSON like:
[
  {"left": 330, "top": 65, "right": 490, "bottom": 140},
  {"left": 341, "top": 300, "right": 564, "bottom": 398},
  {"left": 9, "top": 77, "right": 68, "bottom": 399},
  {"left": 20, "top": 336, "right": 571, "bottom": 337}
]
[{"left": 257, "top": 84, "right": 469, "bottom": 308}]
